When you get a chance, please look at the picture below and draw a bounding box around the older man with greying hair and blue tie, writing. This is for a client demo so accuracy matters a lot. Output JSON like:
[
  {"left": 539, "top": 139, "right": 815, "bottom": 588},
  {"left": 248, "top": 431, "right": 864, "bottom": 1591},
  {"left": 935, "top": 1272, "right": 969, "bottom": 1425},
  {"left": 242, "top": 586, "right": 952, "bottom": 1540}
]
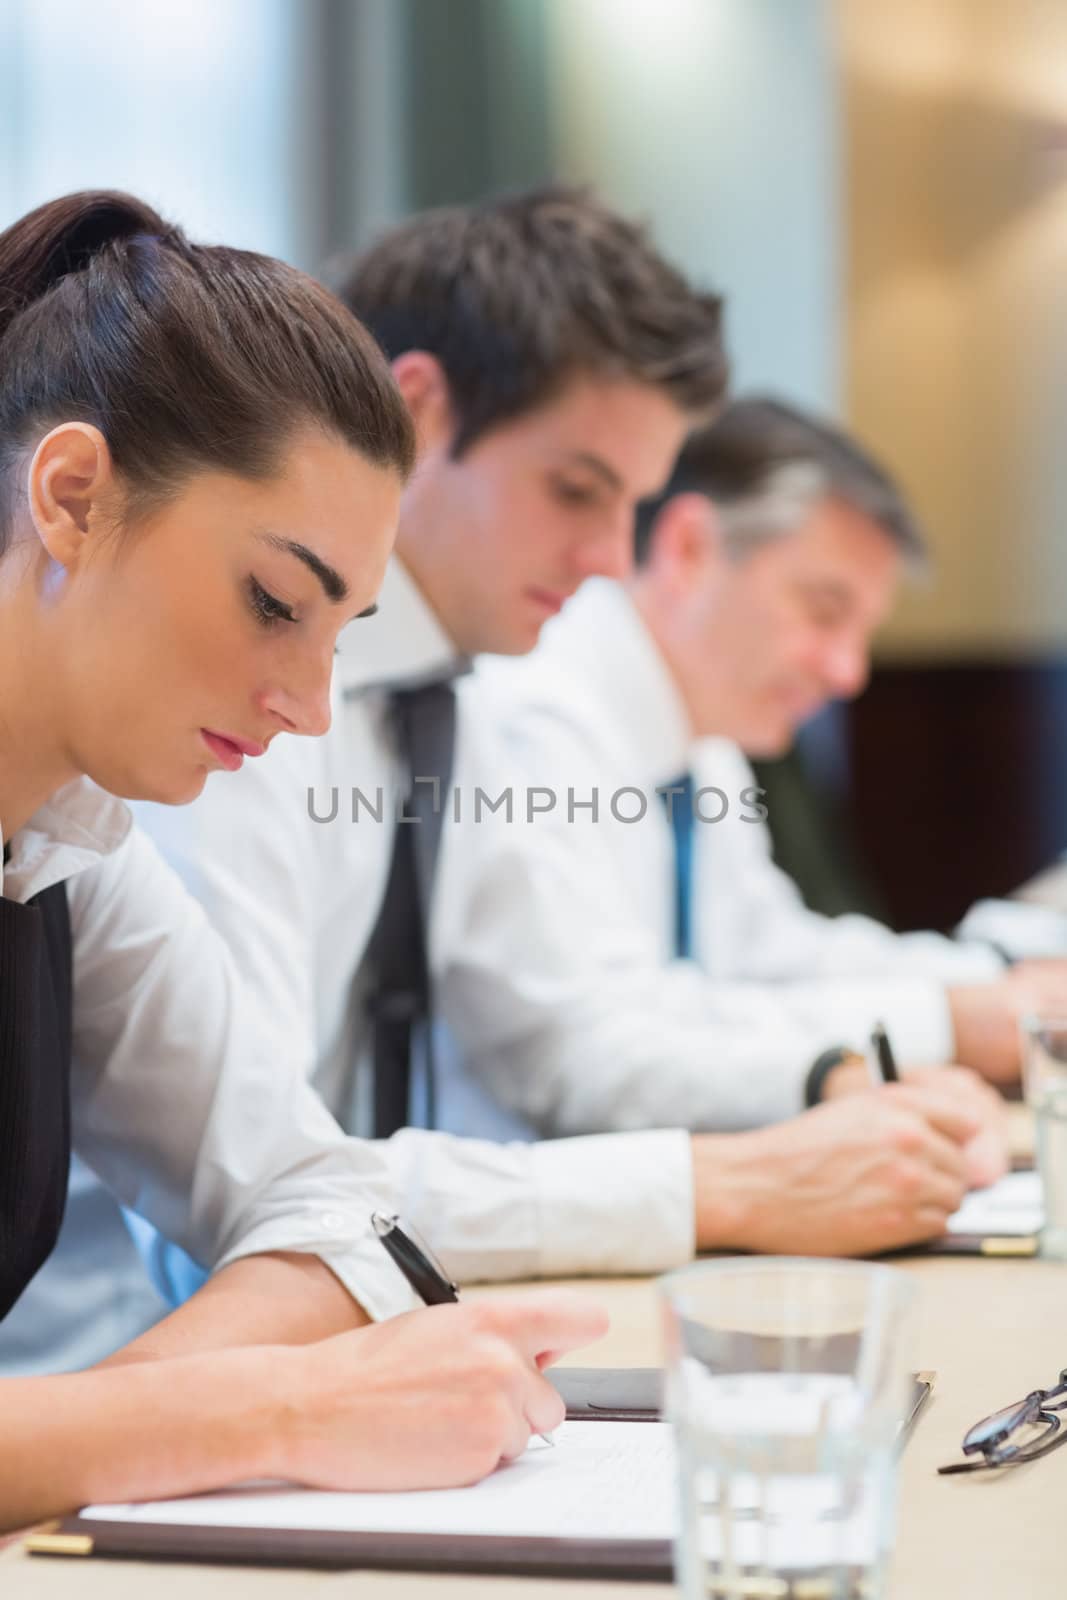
[{"left": 448, "top": 400, "right": 1067, "bottom": 1134}]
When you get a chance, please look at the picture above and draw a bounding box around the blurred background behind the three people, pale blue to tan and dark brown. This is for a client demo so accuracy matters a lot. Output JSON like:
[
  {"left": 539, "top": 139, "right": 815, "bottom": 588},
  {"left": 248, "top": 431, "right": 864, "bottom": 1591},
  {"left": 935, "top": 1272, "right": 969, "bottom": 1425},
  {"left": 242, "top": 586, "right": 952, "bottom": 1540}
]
[{"left": 0, "top": 0, "right": 1067, "bottom": 926}]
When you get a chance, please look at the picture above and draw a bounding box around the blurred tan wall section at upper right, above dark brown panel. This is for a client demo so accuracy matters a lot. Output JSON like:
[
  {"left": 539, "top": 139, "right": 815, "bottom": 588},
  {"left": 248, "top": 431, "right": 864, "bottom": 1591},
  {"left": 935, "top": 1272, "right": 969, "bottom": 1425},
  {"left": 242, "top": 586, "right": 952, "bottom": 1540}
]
[{"left": 838, "top": 0, "right": 1067, "bottom": 659}]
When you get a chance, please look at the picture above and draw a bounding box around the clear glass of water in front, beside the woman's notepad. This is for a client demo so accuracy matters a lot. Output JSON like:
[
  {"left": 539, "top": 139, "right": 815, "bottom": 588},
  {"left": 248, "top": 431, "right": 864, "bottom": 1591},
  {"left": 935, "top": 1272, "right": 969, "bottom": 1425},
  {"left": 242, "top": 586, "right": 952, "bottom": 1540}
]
[{"left": 661, "top": 1258, "right": 913, "bottom": 1600}]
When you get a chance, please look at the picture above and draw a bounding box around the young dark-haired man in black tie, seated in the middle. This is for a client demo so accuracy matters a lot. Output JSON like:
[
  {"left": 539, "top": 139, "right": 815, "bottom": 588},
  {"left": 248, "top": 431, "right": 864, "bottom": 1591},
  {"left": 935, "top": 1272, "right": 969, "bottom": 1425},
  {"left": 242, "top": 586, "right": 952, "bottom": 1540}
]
[{"left": 0, "top": 190, "right": 976, "bottom": 1376}]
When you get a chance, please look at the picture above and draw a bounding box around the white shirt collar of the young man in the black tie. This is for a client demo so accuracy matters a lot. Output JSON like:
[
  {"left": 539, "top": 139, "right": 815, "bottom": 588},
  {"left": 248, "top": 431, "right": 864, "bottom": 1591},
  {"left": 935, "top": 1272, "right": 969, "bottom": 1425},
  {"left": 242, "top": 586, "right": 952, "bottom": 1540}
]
[{"left": 334, "top": 557, "right": 469, "bottom": 694}]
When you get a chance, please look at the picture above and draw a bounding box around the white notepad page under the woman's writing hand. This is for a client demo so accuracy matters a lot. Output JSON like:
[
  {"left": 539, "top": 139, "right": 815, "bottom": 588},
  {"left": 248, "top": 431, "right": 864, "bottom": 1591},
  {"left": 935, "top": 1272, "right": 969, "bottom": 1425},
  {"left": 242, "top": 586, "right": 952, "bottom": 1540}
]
[{"left": 82, "top": 1421, "right": 677, "bottom": 1539}]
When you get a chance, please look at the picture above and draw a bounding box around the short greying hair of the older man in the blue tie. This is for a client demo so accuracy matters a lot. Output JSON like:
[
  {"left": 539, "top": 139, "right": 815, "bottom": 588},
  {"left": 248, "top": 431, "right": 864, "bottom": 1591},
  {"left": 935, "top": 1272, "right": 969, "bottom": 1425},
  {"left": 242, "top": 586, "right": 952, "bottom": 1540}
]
[{"left": 637, "top": 397, "right": 926, "bottom": 568}]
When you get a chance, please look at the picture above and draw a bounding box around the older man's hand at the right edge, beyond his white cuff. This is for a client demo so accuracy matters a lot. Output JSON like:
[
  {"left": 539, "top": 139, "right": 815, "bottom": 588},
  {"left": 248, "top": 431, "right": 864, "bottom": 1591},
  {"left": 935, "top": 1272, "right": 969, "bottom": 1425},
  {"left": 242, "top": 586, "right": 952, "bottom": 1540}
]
[{"left": 947, "top": 962, "right": 1067, "bottom": 1083}]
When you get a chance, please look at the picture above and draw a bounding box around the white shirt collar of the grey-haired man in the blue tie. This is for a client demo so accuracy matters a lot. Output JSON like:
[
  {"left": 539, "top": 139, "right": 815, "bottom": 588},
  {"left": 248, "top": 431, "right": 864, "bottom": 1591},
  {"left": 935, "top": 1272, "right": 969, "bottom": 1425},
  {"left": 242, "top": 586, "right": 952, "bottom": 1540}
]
[{"left": 545, "top": 578, "right": 694, "bottom": 787}]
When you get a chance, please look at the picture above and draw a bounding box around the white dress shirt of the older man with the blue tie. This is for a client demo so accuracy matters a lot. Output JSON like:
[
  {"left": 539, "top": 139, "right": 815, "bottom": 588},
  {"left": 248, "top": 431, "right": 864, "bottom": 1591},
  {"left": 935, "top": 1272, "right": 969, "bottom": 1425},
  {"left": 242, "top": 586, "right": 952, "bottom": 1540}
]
[{"left": 451, "top": 579, "right": 1000, "bottom": 1131}]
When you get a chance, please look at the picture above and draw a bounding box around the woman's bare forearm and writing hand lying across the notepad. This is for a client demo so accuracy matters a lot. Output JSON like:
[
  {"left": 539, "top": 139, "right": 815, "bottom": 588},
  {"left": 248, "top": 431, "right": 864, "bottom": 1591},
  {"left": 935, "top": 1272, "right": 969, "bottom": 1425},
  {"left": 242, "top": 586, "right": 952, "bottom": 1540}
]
[{"left": 0, "top": 1290, "right": 606, "bottom": 1530}]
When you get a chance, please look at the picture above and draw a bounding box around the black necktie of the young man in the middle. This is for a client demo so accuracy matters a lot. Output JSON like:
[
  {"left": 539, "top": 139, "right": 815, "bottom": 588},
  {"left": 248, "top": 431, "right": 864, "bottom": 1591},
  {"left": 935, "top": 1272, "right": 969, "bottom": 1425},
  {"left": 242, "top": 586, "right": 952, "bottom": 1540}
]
[{"left": 368, "top": 683, "right": 456, "bottom": 1139}]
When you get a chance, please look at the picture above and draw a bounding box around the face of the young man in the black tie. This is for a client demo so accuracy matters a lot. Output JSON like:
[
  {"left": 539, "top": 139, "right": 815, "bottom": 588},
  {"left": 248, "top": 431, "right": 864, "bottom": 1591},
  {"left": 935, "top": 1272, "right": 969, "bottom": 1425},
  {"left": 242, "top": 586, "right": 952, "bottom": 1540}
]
[{"left": 397, "top": 378, "right": 688, "bottom": 656}]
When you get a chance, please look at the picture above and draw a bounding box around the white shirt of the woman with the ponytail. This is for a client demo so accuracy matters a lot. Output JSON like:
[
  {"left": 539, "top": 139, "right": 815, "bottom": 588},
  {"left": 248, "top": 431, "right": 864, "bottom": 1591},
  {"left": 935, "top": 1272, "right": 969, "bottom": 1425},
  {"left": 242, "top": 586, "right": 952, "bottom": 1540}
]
[{"left": 0, "top": 779, "right": 413, "bottom": 1358}]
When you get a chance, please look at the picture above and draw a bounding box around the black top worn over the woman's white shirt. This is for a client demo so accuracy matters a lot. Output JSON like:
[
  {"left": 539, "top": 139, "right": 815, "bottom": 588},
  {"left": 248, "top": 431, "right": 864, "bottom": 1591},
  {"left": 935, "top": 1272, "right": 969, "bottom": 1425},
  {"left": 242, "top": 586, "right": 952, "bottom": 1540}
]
[{"left": 0, "top": 850, "right": 72, "bottom": 1320}]
